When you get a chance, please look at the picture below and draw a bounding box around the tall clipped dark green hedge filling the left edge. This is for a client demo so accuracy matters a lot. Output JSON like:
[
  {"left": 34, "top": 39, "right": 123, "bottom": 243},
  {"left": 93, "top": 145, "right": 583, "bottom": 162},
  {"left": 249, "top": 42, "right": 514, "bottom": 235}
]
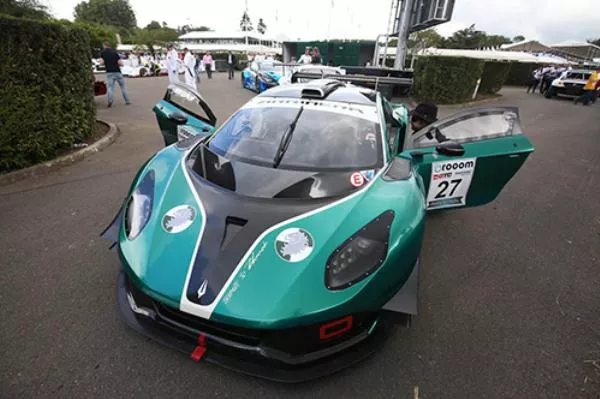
[{"left": 0, "top": 16, "right": 95, "bottom": 173}]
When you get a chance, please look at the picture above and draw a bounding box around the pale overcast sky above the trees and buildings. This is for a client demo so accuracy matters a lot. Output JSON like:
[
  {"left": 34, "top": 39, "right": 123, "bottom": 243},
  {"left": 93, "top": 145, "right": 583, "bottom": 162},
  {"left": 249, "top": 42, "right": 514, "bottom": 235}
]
[{"left": 42, "top": 0, "right": 600, "bottom": 44}]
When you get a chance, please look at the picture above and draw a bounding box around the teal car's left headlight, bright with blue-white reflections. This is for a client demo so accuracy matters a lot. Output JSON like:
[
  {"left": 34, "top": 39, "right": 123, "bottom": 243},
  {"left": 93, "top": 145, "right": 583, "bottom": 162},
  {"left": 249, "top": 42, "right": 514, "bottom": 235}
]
[{"left": 125, "top": 170, "right": 154, "bottom": 240}]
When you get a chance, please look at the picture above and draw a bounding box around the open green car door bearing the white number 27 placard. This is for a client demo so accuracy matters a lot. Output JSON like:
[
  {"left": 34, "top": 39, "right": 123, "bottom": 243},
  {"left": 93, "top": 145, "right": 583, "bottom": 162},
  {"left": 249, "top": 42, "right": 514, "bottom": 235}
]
[{"left": 404, "top": 107, "right": 534, "bottom": 210}]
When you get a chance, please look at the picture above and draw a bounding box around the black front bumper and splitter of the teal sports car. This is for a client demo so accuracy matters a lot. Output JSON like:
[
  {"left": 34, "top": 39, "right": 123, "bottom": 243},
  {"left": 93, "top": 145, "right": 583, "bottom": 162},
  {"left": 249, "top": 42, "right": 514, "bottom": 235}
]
[{"left": 117, "top": 270, "right": 404, "bottom": 383}]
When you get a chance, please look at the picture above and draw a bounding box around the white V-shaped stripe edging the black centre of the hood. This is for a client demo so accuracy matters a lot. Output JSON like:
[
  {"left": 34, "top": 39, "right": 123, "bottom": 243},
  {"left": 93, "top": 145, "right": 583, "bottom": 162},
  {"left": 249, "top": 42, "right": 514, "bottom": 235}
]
[{"left": 179, "top": 139, "right": 387, "bottom": 319}]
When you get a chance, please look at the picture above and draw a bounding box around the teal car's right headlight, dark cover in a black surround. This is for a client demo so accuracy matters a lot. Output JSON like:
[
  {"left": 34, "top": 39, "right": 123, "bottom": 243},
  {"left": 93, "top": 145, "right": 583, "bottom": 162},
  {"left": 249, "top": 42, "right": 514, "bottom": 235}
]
[{"left": 325, "top": 211, "right": 394, "bottom": 290}]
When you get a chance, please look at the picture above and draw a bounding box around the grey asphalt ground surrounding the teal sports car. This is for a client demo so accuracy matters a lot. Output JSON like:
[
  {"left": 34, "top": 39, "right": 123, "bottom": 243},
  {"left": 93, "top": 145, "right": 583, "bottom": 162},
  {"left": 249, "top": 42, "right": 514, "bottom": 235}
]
[{"left": 0, "top": 74, "right": 600, "bottom": 398}]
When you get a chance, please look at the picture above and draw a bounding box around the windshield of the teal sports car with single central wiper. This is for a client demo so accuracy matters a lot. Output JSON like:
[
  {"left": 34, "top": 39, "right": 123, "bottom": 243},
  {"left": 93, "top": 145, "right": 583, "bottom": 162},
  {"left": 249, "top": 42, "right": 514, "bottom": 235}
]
[{"left": 208, "top": 107, "right": 382, "bottom": 170}]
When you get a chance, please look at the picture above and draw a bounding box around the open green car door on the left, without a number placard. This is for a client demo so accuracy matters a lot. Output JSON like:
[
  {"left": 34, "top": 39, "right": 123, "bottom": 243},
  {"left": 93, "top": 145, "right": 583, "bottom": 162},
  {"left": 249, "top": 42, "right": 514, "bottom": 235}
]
[{"left": 152, "top": 84, "right": 217, "bottom": 145}]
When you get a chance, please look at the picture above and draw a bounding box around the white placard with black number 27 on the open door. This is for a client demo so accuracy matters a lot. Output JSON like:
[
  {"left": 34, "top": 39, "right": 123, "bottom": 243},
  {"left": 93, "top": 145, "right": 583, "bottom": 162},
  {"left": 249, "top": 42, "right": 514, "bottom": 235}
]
[{"left": 427, "top": 158, "right": 477, "bottom": 209}]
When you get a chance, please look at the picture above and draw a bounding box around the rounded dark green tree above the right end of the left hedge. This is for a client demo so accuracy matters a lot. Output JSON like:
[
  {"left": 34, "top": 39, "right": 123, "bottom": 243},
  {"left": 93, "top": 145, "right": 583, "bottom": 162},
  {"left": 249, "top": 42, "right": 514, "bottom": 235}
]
[{"left": 74, "top": 0, "right": 137, "bottom": 29}]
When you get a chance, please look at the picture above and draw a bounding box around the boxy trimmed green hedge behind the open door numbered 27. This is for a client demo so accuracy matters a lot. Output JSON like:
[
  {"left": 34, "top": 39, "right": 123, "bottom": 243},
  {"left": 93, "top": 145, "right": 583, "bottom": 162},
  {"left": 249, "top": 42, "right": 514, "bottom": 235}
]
[{"left": 413, "top": 56, "right": 484, "bottom": 104}]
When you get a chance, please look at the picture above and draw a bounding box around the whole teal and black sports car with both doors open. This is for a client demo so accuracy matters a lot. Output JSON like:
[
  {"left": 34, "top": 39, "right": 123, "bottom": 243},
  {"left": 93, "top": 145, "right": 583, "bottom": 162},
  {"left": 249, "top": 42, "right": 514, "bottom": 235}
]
[{"left": 104, "top": 80, "right": 534, "bottom": 382}]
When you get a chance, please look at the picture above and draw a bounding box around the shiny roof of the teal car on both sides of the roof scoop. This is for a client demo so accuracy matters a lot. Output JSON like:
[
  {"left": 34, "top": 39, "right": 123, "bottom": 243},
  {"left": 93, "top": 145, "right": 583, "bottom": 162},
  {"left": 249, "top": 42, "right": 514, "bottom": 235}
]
[{"left": 258, "top": 81, "right": 377, "bottom": 106}]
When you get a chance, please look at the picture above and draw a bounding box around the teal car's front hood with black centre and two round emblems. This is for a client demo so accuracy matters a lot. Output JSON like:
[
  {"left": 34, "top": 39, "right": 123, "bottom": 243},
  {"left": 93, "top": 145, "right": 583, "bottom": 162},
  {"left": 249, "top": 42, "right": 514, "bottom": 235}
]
[{"left": 119, "top": 148, "right": 423, "bottom": 328}]
